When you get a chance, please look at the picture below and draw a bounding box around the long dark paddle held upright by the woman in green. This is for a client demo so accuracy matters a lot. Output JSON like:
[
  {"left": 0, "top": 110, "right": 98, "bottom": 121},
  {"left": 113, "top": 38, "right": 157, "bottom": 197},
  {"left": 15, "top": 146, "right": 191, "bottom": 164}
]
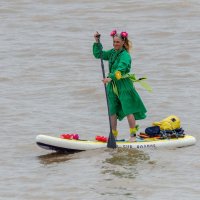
[{"left": 97, "top": 32, "right": 117, "bottom": 149}]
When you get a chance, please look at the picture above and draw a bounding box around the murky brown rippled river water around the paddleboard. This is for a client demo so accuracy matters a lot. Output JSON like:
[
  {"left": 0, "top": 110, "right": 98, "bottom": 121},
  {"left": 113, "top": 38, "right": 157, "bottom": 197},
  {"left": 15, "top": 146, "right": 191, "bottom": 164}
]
[{"left": 0, "top": 0, "right": 200, "bottom": 200}]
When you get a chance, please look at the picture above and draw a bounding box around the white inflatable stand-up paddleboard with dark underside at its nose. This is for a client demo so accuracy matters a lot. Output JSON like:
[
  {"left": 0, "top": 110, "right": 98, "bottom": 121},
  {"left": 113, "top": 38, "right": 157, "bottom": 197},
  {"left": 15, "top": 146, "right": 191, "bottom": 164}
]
[{"left": 36, "top": 135, "right": 196, "bottom": 152}]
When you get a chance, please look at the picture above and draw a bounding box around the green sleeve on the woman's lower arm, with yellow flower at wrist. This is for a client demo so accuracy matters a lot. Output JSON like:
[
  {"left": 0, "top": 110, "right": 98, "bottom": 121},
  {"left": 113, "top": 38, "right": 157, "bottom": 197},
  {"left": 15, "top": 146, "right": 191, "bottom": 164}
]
[{"left": 109, "top": 52, "right": 131, "bottom": 81}]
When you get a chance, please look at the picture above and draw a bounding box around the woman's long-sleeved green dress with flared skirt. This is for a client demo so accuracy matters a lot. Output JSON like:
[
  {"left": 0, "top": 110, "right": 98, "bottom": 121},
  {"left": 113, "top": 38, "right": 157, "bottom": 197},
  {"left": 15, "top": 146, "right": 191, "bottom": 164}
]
[{"left": 93, "top": 43, "right": 147, "bottom": 120}]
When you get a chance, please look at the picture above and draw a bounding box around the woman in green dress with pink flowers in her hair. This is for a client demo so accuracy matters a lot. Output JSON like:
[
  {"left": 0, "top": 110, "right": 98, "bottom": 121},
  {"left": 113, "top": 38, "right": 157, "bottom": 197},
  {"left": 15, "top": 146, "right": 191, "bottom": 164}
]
[{"left": 93, "top": 30, "right": 147, "bottom": 142}]
